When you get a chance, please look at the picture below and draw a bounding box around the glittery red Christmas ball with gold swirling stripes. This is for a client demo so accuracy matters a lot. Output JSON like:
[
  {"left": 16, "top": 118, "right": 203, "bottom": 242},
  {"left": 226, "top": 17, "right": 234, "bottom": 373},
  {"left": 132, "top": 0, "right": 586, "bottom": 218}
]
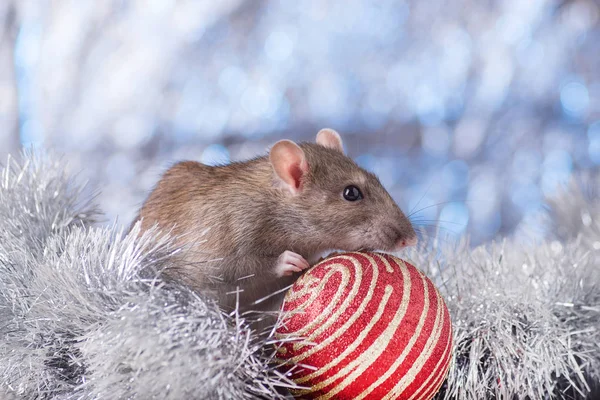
[{"left": 276, "top": 253, "right": 452, "bottom": 400}]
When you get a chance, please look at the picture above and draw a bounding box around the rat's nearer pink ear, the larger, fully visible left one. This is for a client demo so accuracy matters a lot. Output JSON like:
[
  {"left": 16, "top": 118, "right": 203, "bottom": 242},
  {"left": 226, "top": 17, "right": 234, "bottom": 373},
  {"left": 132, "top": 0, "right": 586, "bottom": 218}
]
[{"left": 269, "top": 140, "right": 308, "bottom": 194}]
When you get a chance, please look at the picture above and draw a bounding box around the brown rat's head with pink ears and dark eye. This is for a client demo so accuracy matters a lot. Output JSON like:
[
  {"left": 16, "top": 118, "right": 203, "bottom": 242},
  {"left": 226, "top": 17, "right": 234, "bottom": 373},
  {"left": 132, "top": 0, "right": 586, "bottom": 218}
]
[{"left": 269, "top": 129, "right": 417, "bottom": 251}]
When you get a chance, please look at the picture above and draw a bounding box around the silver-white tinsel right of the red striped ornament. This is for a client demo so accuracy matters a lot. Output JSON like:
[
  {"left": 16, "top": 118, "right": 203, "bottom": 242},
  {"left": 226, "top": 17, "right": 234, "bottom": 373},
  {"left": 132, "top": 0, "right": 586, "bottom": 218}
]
[{"left": 410, "top": 187, "right": 600, "bottom": 400}]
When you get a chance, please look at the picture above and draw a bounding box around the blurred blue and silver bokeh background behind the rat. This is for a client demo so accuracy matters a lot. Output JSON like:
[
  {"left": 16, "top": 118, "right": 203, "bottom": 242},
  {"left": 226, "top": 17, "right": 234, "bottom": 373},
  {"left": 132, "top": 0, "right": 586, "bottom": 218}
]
[{"left": 0, "top": 0, "right": 600, "bottom": 244}]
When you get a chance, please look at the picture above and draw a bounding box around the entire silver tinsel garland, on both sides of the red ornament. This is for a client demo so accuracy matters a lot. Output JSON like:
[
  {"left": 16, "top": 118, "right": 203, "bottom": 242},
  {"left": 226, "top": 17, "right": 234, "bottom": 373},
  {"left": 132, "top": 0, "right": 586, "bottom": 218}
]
[{"left": 0, "top": 155, "right": 600, "bottom": 400}]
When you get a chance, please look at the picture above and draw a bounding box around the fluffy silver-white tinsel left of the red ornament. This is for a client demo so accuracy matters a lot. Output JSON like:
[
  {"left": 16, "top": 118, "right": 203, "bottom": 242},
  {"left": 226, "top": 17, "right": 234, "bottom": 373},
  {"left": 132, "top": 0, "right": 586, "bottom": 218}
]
[{"left": 0, "top": 152, "right": 286, "bottom": 400}]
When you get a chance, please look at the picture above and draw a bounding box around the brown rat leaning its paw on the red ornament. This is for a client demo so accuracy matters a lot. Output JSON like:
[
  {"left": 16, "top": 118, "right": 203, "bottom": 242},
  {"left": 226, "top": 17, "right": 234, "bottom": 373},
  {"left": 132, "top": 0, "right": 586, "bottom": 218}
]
[{"left": 134, "top": 129, "right": 417, "bottom": 320}]
